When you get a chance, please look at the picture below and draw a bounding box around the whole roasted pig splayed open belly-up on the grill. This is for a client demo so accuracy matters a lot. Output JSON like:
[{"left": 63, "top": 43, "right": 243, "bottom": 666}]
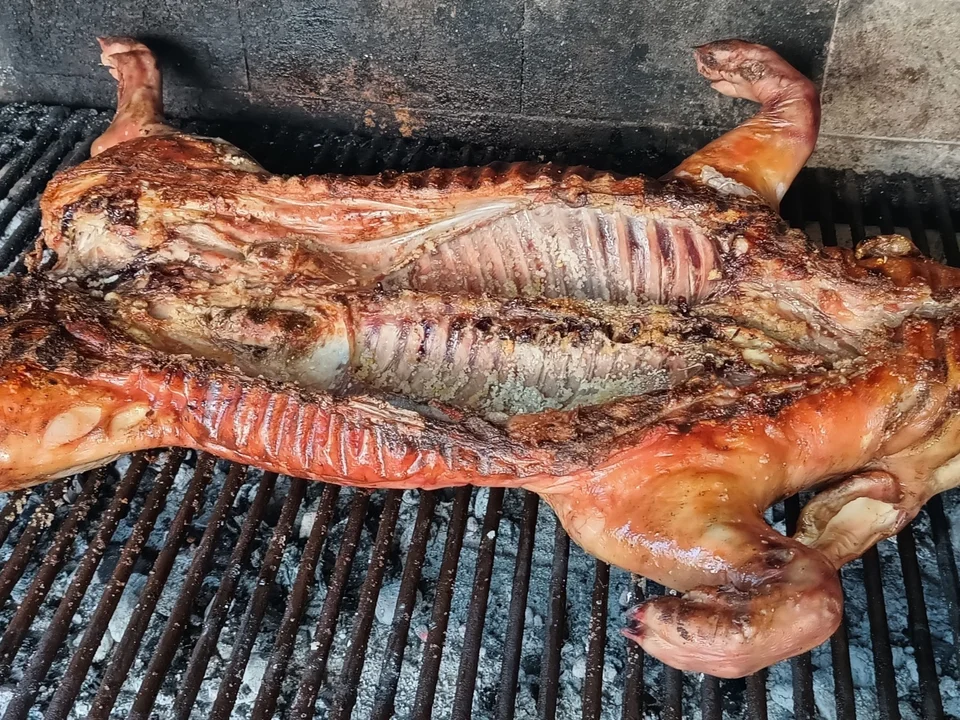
[{"left": 0, "top": 38, "right": 960, "bottom": 677}]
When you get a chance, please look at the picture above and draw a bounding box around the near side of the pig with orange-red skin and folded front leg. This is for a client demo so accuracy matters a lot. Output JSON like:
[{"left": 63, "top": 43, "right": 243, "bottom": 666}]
[{"left": 7, "top": 278, "right": 960, "bottom": 675}]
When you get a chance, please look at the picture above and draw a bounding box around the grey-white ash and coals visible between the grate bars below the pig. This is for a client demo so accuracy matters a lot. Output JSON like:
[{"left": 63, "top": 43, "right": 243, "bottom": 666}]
[{"left": 0, "top": 456, "right": 960, "bottom": 720}]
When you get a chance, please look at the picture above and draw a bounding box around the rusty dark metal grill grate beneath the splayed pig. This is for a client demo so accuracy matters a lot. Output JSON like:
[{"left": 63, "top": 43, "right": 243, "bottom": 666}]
[{"left": 0, "top": 105, "right": 960, "bottom": 720}]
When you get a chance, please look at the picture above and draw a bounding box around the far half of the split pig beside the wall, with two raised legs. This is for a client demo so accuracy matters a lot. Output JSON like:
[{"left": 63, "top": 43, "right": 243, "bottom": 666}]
[{"left": 32, "top": 39, "right": 960, "bottom": 352}]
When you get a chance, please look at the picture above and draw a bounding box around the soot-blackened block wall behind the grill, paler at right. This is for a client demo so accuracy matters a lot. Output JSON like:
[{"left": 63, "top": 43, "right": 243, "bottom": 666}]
[{"left": 0, "top": 0, "right": 960, "bottom": 177}]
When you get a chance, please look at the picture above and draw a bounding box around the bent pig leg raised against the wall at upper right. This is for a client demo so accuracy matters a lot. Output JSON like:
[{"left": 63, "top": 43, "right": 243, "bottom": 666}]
[{"left": 666, "top": 40, "right": 820, "bottom": 209}]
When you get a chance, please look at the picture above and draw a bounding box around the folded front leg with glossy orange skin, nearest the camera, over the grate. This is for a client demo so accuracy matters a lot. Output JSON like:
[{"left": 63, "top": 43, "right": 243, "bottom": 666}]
[{"left": 544, "top": 470, "right": 843, "bottom": 678}]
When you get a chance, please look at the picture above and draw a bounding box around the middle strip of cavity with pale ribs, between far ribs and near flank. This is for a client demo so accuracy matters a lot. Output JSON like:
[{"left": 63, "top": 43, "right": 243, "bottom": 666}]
[{"left": 105, "top": 273, "right": 827, "bottom": 415}]
